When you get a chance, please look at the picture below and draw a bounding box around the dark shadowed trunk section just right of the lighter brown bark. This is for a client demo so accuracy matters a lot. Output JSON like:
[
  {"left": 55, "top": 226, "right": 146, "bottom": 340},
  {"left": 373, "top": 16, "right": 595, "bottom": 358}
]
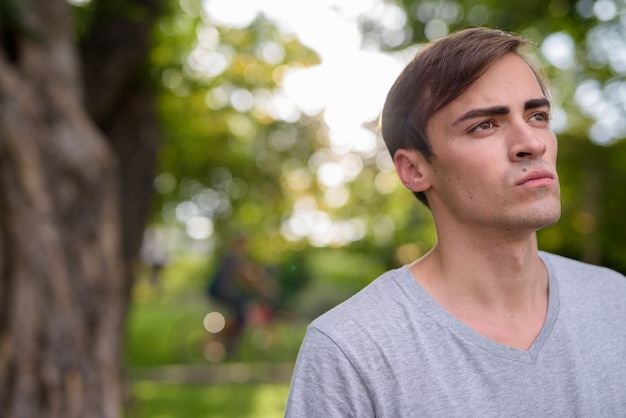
[{"left": 81, "top": 0, "right": 162, "bottom": 298}]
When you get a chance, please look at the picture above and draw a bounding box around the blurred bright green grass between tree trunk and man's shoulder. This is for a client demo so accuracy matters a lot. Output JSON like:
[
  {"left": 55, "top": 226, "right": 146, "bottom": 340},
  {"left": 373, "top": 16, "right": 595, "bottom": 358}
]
[{"left": 125, "top": 256, "right": 305, "bottom": 418}]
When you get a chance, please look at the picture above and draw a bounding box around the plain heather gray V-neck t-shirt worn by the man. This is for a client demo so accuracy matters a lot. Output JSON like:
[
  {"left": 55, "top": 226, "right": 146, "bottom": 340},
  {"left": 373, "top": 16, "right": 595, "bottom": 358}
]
[{"left": 285, "top": 252, "right": 626, "bottom": 418}]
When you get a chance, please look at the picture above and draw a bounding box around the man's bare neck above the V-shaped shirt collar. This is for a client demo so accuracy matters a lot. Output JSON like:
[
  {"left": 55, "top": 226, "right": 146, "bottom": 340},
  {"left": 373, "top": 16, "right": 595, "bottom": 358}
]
[{"left": 410, "top": 229, "right": 548, "bottom": 349}]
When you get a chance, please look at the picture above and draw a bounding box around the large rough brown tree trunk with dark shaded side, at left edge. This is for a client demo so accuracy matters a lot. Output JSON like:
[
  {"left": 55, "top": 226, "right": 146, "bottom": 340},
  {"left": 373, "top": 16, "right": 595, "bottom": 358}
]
[{"left": 0, "top": 0, "right": 161, "bottom": 418}]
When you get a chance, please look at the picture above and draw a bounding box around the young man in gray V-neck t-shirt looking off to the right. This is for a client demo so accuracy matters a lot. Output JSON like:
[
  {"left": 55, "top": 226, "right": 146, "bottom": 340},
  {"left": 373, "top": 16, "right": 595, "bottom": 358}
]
[{"left": 286, "top": 29, "right": 626, "bottom": 418}]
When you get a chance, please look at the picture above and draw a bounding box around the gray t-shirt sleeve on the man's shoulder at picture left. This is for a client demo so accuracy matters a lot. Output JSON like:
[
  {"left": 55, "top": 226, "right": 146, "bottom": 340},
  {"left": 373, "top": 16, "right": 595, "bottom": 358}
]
[{"left": 285, "top": 327, "right": 375, "bottom": 418}]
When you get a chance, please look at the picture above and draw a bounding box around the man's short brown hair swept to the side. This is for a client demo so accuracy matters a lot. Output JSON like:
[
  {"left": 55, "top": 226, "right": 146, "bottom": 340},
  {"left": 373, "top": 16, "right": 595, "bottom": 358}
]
[{"left": 381, "top": 28, "right": 547, "bottom": 206}]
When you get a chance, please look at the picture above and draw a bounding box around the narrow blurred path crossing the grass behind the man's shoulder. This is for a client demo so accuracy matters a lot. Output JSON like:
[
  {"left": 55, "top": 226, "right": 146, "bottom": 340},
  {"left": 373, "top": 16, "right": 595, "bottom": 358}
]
[{"left": 126, "top": 363, "right": 294, "bottom": 384}]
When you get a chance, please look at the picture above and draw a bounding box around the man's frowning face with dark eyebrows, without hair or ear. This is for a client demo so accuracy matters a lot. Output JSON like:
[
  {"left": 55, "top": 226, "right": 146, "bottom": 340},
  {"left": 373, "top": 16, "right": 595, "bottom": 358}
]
[{"left": 427, "top": 53, "right": 560, "bottom": 232}]
